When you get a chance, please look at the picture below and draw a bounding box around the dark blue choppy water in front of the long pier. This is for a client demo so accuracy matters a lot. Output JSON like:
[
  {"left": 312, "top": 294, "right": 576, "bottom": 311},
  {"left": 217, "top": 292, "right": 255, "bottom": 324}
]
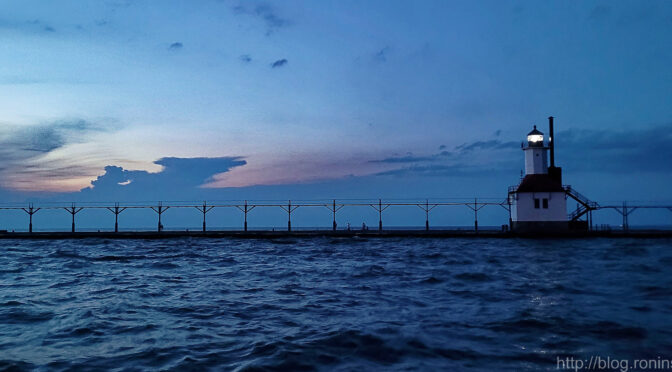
[{"left": 0, "top": 238, "right": 672, "bottom": 370}]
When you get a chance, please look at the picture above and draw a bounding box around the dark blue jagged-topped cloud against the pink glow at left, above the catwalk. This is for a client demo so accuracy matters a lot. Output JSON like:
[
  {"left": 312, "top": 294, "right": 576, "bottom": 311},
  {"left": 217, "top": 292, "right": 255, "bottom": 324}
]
[{"left": 81, "top": 156, "right": 247, "bottom": 200}]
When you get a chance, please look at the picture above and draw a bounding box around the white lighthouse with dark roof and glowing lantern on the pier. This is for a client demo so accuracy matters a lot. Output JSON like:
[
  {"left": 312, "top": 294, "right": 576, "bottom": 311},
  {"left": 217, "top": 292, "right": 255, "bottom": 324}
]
[{"left": 509, "top": 118, "right": 569, "bottom": 232}]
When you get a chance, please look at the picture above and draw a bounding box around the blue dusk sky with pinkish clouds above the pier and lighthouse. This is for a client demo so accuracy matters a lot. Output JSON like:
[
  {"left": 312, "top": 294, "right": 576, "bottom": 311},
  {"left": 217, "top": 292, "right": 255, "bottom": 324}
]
[{"left": 0, "top": 0, "right": 672, "bottom": 228}]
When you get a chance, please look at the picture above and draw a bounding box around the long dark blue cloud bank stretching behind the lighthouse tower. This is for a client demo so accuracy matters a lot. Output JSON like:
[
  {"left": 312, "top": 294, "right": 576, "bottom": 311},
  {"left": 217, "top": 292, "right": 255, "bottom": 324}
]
[{"left": 370, "top": 123, "right": 672, "bottom": 176}]
